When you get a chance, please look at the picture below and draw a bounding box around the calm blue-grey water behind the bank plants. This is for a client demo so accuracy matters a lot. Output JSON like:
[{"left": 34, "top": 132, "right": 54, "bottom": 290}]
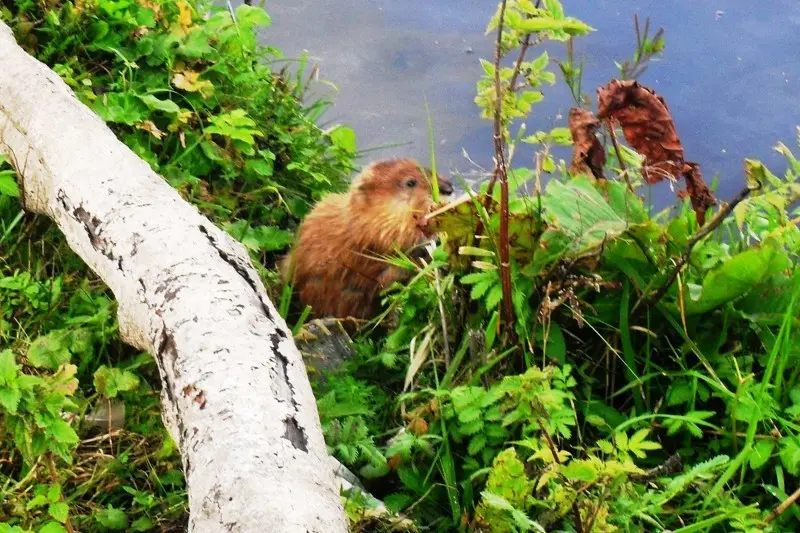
[{"left": 256, "top": 0, "right": 800, "bottom": 205}]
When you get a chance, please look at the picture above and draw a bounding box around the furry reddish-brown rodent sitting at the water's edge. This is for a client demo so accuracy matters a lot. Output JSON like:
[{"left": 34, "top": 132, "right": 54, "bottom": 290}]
[{"left": 280, "top": 159, "right": 453, "bottom": 319}]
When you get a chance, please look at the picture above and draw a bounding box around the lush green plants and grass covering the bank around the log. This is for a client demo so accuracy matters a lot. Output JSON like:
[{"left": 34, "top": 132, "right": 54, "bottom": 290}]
[{"left": 0, "top": 0, "right": 800, "bottom": 533}]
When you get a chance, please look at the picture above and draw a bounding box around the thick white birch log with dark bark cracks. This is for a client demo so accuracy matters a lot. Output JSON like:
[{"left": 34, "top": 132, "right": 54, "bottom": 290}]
[{"left": 0, "top": 22, "right": 346, "bottom": 533}]
